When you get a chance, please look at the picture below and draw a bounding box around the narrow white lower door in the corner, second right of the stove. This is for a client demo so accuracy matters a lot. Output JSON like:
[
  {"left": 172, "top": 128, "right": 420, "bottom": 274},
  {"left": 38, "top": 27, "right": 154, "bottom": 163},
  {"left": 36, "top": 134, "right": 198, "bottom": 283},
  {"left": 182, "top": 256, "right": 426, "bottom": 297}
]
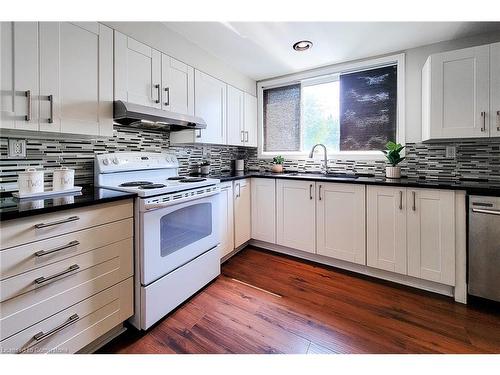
[{"left": 233, "top": 179, "right": 252, "bottom": 248}]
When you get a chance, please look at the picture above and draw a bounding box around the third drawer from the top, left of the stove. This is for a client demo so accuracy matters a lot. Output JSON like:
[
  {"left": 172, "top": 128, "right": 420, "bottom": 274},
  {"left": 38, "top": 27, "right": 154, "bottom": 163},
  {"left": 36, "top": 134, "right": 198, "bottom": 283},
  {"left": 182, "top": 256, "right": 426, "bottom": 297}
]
[{"left": 0, "top": 238, "right": 133, "bottom": 340}]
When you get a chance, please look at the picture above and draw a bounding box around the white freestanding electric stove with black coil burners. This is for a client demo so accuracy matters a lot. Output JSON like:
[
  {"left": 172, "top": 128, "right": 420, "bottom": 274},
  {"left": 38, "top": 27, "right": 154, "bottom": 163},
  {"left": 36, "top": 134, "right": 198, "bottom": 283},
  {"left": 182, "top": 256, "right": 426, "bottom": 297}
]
[{"left": 94, "top": 152, "right": 220, "bottom": 330}]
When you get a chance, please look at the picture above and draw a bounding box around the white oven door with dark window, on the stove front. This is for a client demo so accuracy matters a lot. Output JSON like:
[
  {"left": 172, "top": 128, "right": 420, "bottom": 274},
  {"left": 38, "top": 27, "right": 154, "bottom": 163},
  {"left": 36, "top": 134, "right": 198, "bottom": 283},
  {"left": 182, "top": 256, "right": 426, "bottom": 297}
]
[{"left": 139, "top": 194, "right": 220, "bottom": 285}]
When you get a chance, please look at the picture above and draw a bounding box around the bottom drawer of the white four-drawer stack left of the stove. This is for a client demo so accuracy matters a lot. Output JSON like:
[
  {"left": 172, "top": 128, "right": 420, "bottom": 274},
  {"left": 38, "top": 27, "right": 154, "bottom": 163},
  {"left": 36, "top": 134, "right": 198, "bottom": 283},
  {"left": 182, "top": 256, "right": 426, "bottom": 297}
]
[{"left": 0, "top": 278, "right": 133, "bottom": 353}]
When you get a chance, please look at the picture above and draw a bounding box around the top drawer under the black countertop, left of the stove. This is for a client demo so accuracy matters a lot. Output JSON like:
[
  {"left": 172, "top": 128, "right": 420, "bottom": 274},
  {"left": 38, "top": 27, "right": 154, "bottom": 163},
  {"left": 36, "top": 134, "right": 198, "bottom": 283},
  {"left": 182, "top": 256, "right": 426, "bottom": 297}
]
[{"left": 0, "top": 200, "right": 133, "bottom": 249}]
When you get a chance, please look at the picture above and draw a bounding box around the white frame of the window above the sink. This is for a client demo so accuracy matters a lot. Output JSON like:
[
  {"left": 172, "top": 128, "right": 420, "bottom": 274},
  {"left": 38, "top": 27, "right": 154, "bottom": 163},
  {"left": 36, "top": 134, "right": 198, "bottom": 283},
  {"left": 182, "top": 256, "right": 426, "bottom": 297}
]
[{"left": 257, "top": 53, "right": 406, "bottom": 160}]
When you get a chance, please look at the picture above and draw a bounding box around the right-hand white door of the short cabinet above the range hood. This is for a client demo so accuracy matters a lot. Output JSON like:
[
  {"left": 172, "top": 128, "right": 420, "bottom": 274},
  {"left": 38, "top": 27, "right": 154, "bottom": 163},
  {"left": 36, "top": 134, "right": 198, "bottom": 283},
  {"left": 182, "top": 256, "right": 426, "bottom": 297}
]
[{"left": 161, "top": 55, "right": 194, "bottom": 115}]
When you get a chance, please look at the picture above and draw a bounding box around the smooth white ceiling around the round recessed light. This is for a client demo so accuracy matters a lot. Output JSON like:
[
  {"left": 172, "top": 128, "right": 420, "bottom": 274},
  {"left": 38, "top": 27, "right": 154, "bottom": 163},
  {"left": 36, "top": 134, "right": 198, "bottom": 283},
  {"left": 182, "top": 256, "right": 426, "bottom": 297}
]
[{"left": 164, "top": 22, "right": 500, "bottom": 80}]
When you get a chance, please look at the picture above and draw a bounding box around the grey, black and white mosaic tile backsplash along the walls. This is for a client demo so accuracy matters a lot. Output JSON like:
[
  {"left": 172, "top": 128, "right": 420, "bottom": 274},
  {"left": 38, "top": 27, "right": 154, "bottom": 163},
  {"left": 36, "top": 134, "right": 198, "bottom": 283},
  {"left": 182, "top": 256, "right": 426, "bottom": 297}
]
[{"left": 0, "top": 126, "right": 500, "bottom": 191}]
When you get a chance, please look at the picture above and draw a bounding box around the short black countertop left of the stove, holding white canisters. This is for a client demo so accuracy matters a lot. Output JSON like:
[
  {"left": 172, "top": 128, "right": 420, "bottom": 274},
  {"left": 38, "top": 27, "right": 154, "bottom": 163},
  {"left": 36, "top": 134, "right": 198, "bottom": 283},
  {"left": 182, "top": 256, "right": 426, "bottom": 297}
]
[{"left": 0, "top": 185, "right": 135, "bottom": 221}]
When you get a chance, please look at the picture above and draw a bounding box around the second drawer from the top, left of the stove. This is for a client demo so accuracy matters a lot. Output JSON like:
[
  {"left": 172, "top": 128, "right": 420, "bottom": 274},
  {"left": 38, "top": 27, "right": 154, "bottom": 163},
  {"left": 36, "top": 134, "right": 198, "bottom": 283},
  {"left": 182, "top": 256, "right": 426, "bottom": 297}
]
[{"left": 0, "top": 219, "right": 134, "bottom": 280}]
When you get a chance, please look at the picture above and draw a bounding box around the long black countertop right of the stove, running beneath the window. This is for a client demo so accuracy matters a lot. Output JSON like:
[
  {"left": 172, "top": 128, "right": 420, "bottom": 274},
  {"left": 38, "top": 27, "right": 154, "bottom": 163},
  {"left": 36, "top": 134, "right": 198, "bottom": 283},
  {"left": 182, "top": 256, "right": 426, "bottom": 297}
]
[{"left": 190, "top": 171, "right": 500, "bottom": 196}]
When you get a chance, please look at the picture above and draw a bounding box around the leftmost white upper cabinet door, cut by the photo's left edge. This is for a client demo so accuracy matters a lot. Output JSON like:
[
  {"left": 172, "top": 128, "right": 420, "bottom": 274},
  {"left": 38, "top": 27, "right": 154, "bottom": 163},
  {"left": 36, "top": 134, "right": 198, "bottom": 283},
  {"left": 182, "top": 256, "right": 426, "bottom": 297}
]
[{"left": 0, "top": 22, "right": 39, "bottom": 130}]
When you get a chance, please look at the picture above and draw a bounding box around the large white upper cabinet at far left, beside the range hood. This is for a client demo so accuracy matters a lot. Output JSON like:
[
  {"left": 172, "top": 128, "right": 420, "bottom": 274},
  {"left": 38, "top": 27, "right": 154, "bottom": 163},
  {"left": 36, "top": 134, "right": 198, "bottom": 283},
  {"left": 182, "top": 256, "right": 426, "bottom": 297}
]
[{"left": 2, "top": 22, "right": 113, "bottom": 136}]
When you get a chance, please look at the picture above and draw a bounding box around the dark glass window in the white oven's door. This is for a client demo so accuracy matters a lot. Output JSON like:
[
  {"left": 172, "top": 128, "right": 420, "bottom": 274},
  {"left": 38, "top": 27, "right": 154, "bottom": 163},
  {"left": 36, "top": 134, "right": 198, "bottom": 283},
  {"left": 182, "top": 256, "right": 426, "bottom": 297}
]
[{"left": 160, "top": 203, "right": 212, "bottom": 257}]
